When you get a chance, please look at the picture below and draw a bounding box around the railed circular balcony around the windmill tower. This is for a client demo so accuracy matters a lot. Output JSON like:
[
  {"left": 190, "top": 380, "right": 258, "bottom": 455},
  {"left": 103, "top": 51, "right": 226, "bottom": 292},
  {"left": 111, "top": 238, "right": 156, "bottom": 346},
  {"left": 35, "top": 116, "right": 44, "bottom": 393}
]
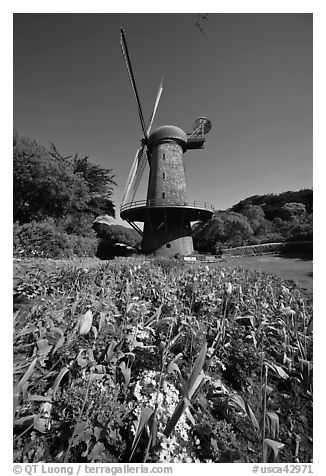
[{"left": 120, "top": 198, "right": 215, "bottom": 222}]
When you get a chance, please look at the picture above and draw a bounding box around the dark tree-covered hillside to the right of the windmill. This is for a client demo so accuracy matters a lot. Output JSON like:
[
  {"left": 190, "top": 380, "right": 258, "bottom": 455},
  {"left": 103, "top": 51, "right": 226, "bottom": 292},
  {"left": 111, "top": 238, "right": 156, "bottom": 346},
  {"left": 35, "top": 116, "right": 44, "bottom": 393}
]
[{"left": 193, "top": 189, "right": 313, "bottom": 253}]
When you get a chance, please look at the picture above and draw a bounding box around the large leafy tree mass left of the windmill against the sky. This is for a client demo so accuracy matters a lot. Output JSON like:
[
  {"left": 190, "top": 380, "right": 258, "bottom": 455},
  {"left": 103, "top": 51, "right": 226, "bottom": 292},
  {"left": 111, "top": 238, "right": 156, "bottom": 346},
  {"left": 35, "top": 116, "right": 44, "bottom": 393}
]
[{"left": 13, "top": 131, "right": 115, "bottom": 234}]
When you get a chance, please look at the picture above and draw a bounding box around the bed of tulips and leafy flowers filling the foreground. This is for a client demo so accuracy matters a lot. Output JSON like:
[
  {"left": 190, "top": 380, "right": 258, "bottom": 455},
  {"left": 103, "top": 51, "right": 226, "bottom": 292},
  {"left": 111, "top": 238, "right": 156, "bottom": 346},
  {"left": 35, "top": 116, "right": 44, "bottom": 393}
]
[{"left": 13, "top": 259, "right": 312, "bottom": 463}]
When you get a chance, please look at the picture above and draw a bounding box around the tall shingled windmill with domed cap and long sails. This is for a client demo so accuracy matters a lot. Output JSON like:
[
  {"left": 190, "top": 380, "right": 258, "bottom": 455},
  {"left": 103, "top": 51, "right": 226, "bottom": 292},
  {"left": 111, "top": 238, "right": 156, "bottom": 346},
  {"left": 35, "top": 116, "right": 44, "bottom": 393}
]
[{"left": 120, "top": 28, "right": 214, "bottom": 257}]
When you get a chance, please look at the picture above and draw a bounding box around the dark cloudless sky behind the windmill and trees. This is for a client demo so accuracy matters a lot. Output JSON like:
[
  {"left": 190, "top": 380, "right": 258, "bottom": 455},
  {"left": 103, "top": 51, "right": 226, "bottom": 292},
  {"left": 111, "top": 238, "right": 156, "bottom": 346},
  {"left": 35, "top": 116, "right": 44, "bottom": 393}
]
[{"left": 14, "top": 13, "right": 313, "bottom": 223}]
